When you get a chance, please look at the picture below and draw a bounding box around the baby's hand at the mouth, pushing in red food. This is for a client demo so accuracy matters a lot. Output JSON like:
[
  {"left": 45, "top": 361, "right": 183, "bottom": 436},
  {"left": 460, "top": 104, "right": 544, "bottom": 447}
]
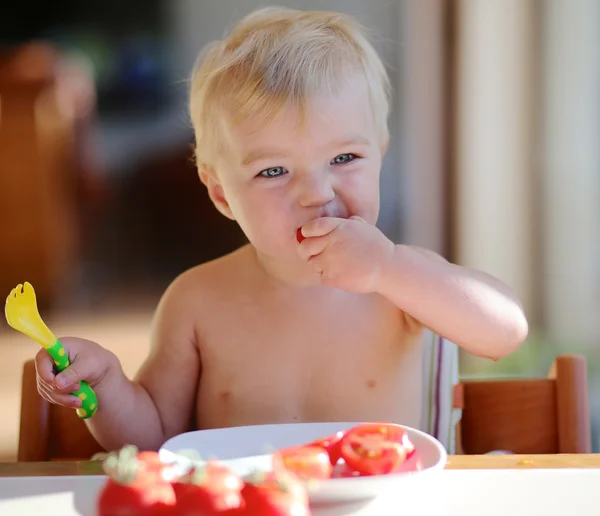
[{"left": 298, "top": 217, "right": 395, "bottom": 293}]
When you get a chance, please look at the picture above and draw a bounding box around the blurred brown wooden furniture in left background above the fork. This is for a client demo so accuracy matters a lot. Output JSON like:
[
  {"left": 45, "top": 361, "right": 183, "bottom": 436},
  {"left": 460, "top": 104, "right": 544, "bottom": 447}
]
[{"left": 0, "top": 43, "right": 105, "bottom": 305}]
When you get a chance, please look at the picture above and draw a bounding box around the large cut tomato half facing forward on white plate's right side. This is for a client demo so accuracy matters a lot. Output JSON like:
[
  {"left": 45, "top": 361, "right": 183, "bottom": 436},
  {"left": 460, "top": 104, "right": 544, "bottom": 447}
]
[{"left": 341, "top": 423, "right": 414, "bottom": 475}]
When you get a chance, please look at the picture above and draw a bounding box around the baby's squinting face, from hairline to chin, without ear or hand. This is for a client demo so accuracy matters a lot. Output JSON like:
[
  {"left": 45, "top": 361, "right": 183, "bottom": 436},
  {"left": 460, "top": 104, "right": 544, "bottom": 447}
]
[{"left": 218, "top": 81, "right": 382, "bottom": 260}]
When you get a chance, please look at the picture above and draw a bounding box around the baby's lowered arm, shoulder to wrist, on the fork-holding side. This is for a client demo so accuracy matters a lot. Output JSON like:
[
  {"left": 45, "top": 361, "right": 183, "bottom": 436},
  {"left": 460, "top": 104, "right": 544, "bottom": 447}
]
[{"left": 87, "top": 274, "right": 200, "bottom": 449}]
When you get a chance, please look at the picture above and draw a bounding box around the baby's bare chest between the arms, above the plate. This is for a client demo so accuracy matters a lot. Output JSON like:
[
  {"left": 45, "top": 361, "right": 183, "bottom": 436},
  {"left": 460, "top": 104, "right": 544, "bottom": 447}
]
[{"left": 198, "top": 292, "right": 421, "bottom": 427}]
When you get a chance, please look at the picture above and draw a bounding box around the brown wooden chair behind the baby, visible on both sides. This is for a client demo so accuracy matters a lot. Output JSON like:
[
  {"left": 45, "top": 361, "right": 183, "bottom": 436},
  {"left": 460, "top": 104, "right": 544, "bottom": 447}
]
[{"left": 18, "top": 355, "right": 591, "bottom": 462}]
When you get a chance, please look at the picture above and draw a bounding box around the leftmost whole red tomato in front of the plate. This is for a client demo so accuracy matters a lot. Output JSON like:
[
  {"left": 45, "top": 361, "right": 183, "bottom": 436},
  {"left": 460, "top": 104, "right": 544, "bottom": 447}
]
[{"left": 98, "top": 478, "right": 175, "bottom": 516}]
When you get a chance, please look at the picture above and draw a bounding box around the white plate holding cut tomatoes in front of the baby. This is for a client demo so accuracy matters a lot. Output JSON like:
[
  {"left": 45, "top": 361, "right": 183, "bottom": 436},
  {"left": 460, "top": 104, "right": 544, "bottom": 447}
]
[{"left": 159, "top": 422, "right": 447, "bottom": 503}]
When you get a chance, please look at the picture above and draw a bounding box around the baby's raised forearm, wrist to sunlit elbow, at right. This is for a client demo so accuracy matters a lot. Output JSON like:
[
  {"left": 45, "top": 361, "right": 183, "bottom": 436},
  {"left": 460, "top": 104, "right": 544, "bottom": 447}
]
[{"left": 377, "top": 245, "right": 528, "bottom": 358}]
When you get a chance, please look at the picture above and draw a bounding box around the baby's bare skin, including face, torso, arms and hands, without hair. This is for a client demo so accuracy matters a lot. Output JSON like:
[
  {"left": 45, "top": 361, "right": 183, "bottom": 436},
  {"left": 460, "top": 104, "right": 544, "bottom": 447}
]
[{"left": 36, "top": 76, "right": 527, "bottom": 449}]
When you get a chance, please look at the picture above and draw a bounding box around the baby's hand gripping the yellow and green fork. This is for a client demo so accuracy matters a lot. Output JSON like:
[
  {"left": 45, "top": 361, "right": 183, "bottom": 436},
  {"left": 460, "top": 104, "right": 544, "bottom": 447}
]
[{"left": 35, "top": 337, "right": 120, "bottom": 408}]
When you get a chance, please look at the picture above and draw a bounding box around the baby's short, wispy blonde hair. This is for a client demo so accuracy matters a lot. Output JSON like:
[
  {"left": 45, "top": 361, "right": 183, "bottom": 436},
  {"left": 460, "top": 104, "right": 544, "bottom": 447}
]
[{"left": 190, "top": 7, "right": 390, "bottom": 164}]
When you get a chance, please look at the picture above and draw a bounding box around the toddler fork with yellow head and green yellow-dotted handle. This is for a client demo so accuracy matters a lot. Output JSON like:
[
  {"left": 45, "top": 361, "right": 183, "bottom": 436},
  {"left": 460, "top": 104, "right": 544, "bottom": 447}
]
[{"left": 4, "top": 282, "right": 98, "bottom": 419}]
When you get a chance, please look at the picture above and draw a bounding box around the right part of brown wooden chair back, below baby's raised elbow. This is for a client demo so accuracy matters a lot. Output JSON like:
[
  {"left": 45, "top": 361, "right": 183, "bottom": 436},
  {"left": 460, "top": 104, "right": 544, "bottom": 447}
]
[{"left": 455, "top": 355, "right": 592, "bottom": 454}]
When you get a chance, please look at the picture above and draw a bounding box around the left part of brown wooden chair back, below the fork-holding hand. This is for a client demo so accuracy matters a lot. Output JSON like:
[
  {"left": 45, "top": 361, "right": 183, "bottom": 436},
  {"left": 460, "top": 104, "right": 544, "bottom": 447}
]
[{"left": 17, "top": 360, "right": 104, "bottom": 462}]
